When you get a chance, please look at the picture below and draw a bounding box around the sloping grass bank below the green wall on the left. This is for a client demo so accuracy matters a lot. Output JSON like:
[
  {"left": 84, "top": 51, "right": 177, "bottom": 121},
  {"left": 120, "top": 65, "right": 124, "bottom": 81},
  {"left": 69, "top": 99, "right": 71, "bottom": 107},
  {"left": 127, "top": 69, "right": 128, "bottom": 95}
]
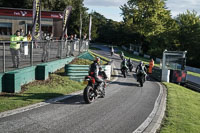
[{"left": 0, "top": 69, "right": 85, "bottom": 112}]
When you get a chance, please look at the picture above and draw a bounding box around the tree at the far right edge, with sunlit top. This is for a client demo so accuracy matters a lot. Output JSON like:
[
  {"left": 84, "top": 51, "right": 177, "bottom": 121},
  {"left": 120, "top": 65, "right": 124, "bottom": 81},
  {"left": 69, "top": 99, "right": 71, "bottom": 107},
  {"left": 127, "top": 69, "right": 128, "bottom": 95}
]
[{"left": 176, "top": 11, "right": 200, "bottom": 67}]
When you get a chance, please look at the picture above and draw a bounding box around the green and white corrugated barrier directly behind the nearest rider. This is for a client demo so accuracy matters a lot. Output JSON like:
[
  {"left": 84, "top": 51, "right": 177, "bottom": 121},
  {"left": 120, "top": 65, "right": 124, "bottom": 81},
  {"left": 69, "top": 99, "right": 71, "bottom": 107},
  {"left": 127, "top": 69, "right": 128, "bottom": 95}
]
[{"left": 65, "top": 64, "right": 111, "bottom": 81}]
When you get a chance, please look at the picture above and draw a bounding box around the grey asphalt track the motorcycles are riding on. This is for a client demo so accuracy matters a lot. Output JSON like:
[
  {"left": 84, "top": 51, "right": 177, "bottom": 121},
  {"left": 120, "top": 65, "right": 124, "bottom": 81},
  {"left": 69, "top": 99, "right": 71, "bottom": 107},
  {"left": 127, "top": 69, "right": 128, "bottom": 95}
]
[{"left": 0, "top": 45, "right": 160, "bottom": 133}]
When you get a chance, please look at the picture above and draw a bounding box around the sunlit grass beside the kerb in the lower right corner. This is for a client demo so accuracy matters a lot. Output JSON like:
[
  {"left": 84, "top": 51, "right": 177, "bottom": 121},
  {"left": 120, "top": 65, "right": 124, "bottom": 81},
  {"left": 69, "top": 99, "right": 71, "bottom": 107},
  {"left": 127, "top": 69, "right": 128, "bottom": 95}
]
[{"left": 159, "top": 83, "right": 200, "bottom": 133}]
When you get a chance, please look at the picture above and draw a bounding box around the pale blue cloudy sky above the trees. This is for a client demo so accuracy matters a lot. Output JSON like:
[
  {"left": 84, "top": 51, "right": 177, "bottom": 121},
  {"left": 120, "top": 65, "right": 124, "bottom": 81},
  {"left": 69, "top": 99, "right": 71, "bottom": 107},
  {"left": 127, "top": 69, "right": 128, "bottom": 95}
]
[{"left": 84, "top": 0, "right": 200, "bottom": 21}]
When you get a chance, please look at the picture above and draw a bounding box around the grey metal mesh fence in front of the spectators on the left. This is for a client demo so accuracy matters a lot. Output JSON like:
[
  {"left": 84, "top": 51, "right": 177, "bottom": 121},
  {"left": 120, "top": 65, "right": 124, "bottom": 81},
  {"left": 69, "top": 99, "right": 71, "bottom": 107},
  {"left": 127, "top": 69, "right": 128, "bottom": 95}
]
[{"left": 0, "top": 40, "right": 89, "bottom": 73}]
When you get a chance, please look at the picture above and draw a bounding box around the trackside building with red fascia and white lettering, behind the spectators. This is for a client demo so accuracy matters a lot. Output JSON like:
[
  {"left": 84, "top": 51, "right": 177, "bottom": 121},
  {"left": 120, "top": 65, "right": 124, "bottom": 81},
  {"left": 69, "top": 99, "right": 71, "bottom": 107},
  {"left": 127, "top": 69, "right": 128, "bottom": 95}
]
[{"left": 0, "top": 7, "right": 63, "bottom": 40}]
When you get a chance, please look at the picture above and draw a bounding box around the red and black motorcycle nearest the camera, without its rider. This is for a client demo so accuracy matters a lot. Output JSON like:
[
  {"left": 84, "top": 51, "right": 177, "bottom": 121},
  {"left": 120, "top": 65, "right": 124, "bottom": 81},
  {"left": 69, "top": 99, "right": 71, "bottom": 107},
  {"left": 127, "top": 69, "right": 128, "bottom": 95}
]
[{"left": 83, "top": 76, "right": 106, "bottom": 104}]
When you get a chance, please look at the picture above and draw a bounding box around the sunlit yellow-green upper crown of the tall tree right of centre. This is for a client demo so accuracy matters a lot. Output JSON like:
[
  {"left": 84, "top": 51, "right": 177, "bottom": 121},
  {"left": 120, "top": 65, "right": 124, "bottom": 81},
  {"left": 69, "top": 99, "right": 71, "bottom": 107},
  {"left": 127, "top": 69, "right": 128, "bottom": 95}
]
[{"left": 121, "top": 0, "right": 170, "bottom": 37}]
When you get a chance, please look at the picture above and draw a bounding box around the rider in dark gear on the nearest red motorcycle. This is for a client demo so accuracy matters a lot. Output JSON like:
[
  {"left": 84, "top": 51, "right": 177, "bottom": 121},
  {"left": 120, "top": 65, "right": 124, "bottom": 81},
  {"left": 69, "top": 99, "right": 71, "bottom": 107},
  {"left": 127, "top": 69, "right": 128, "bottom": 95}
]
[{"left": 89, "top": 57, "right": 103, "bottom": 95}]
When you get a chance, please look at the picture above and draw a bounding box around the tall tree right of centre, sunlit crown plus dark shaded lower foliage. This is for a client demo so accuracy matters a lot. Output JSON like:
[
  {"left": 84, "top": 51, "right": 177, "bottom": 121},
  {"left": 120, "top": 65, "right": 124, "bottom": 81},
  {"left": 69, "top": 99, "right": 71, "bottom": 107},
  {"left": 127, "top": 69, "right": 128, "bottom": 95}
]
[{"left": 120, "top": 0, "right": 172, "bottom": 54}]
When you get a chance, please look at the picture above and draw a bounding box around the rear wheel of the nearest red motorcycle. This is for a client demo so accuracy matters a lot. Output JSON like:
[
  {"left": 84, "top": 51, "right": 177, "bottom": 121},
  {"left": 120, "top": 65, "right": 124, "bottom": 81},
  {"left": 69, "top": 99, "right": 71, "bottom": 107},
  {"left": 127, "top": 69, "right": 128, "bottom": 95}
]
[{"left": 83, "top": 86, "right": 95, "bottom": 104}]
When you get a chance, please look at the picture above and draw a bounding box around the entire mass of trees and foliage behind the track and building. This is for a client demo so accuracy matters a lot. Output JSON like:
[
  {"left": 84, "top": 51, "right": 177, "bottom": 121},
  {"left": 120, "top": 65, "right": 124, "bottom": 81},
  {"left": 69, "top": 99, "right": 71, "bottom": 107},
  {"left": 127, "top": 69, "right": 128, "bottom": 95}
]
[{"left": 0, "top": 0, "right": 200, "bottom": 67}]
